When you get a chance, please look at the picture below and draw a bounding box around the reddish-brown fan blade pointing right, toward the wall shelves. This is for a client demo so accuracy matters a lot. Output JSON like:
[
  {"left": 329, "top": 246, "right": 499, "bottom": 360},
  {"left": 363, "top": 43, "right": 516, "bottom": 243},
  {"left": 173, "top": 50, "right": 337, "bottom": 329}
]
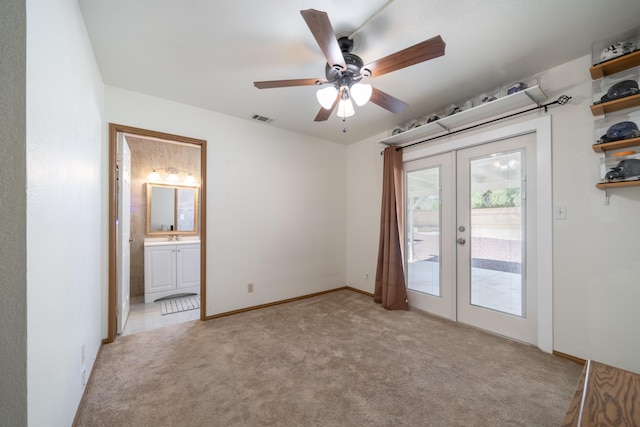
[{"left": 364, "top": 36, "right": 445, "bottom": 77}]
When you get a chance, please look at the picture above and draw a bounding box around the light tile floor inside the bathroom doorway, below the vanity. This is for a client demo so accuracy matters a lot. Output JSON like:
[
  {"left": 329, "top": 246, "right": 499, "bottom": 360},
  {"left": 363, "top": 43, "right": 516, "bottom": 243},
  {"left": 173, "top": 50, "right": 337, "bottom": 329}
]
[{"left": 120, "top": 297, "right": 200, "bottom": 336}]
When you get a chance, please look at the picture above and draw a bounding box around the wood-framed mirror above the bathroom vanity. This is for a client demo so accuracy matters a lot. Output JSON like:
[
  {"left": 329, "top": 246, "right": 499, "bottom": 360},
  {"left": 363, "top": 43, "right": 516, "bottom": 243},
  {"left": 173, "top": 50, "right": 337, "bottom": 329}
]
[{"left": 147, "top": 183, "right": 198, "bottom": 236}]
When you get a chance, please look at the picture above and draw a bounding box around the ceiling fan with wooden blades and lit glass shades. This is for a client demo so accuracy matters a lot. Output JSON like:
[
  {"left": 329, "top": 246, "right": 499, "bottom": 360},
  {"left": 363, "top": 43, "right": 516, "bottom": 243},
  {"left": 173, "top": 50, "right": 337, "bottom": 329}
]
[{"left": 253, "top": 9, "right": 445, "bottom": 122}]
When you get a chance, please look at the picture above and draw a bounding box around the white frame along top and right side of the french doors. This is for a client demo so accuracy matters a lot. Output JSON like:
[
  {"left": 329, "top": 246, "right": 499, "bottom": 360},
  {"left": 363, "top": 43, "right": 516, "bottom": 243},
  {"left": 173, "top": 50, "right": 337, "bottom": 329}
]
[{"left": 402, "top": 116, "right": 553, "bottom": 353}]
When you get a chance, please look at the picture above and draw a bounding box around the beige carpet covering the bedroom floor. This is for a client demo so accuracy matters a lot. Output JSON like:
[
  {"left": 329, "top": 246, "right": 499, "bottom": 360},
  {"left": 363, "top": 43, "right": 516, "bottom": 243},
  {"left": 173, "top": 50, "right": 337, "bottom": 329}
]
[{"left": 77, "top": 290, "right": 582, "bottom": 427}]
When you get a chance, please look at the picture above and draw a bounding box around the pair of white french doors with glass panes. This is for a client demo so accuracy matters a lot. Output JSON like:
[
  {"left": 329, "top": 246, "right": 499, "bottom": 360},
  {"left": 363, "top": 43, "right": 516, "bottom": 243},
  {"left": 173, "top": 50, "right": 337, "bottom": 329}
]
[{"left": 405, "top": 134, "right": 537, "bottom": 344}]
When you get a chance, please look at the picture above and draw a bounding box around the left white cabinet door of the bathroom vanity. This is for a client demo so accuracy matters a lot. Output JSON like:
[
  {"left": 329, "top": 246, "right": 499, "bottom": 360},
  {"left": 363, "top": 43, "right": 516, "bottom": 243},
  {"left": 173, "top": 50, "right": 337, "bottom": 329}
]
[{"left": 144, "top": 245, "right": 176, "bottom": 294}]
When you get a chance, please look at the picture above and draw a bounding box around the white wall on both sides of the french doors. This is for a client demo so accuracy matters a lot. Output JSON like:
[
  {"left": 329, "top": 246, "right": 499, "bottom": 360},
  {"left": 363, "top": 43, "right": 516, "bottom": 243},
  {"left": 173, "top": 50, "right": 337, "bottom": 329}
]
[{"left": 347, "top": 57, "right": 640, "bottom": 372}]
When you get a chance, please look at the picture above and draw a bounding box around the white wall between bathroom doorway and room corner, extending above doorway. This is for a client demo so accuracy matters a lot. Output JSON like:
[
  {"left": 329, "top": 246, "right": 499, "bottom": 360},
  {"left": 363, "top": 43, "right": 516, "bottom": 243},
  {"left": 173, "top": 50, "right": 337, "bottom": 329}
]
[{"left": 104, "top": 86, "right": 346, "bottom": 315}]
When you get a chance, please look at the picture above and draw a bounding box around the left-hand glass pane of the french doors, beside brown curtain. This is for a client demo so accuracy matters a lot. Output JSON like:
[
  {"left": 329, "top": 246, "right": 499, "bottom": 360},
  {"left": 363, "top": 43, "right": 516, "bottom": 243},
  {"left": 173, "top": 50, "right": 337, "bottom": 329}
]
[{"left": 405, "top": 167, "right": 441, "bottom": 297}]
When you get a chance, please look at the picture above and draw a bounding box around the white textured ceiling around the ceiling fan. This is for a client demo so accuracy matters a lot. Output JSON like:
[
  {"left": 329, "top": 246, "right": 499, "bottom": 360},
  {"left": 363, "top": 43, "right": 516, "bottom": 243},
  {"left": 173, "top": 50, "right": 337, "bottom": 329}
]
[{"left": 78, "top": 0, "right": 640, "bottom": 144}]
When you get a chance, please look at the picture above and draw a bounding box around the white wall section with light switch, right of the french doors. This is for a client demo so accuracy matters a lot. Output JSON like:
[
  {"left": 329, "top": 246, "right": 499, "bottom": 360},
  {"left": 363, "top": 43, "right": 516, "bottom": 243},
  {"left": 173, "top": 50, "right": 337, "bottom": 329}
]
[{"left": 547, "top": 57, "right": 640, "bottom": 372}]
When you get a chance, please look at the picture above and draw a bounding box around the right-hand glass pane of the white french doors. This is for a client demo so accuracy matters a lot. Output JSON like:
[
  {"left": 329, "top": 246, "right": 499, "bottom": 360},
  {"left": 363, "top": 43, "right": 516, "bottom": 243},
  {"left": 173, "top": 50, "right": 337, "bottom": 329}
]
[{"left": 470, "top": 151, "right": 524, "bottom": 316}]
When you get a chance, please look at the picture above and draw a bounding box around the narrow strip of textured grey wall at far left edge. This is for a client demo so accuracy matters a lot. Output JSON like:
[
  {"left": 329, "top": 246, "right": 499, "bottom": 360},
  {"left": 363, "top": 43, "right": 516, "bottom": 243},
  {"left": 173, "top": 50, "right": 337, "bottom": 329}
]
[{"left": 0, "top": 0, "right": 27, "bottom": 426}]
